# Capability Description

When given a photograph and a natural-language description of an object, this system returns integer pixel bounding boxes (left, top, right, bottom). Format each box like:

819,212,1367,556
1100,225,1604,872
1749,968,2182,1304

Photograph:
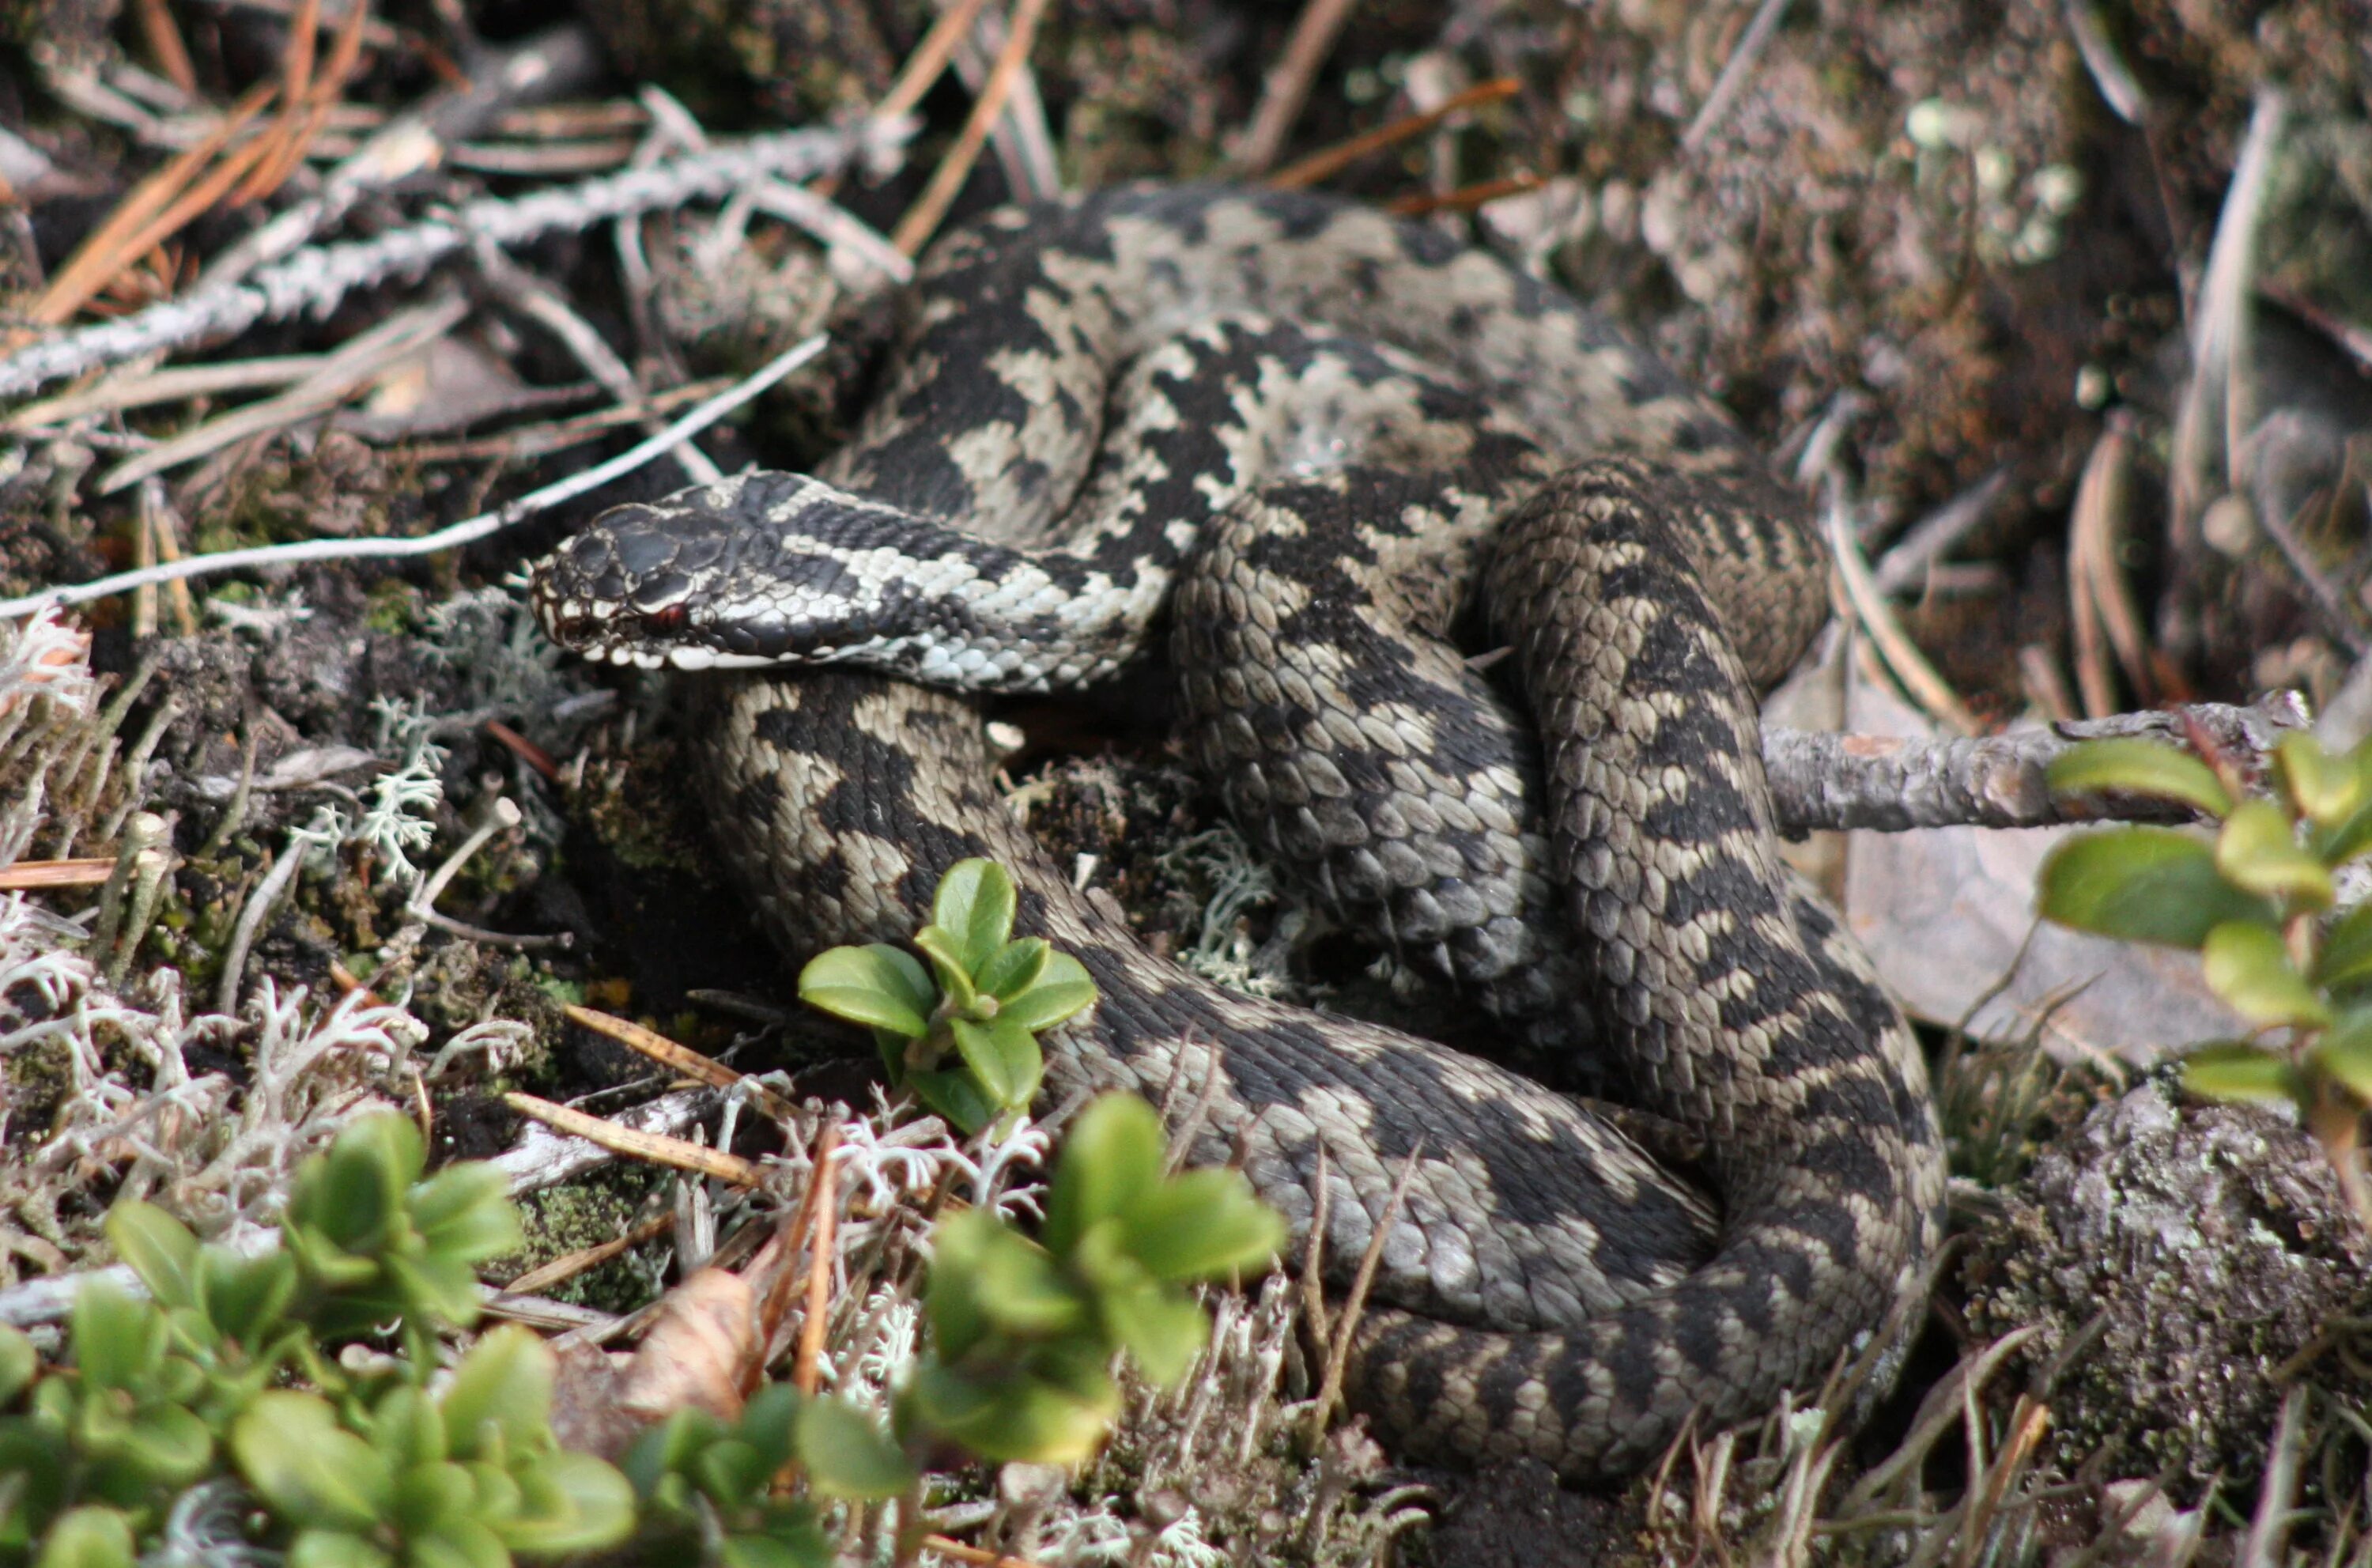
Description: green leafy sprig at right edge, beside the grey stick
2038,735,2372,1224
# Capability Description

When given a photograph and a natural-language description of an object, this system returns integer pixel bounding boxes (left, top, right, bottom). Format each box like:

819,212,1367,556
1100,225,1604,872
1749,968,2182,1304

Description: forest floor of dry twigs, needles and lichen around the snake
0,0,2372,1568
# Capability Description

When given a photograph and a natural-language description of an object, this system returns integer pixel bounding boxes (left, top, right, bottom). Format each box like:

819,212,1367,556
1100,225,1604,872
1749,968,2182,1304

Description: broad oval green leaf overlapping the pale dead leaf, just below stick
2035,828,2279,949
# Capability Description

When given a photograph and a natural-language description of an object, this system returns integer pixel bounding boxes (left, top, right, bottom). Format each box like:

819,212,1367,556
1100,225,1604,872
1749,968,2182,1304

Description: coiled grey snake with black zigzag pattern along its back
534,187,1943,1478
